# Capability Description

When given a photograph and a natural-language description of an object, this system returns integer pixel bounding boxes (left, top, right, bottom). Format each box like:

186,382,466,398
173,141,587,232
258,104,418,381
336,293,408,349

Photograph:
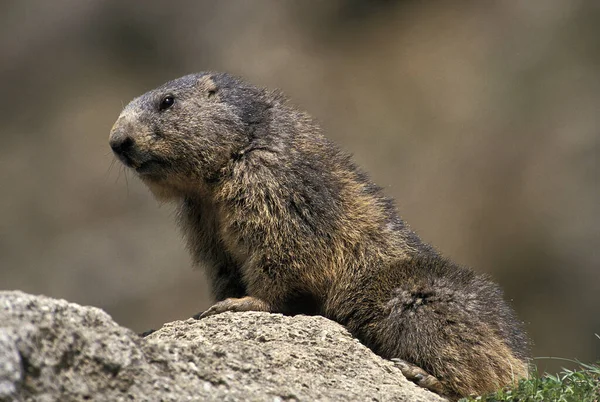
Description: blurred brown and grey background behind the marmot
0,0,600,371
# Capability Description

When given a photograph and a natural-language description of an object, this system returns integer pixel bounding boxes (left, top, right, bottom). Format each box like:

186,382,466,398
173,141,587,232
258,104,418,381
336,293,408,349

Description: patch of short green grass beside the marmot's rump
461,362,600,402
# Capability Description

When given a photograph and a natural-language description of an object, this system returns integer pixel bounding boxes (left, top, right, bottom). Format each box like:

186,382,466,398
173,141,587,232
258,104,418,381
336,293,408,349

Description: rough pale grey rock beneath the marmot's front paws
0,291,443,401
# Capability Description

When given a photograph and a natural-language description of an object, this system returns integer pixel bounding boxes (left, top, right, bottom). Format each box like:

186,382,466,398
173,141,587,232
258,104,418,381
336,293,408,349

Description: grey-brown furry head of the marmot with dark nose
109,73,271,199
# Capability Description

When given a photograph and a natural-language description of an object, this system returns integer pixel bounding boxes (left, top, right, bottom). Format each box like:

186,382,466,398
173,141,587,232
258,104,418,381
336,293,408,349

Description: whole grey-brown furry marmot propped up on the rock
110,72,528,399
